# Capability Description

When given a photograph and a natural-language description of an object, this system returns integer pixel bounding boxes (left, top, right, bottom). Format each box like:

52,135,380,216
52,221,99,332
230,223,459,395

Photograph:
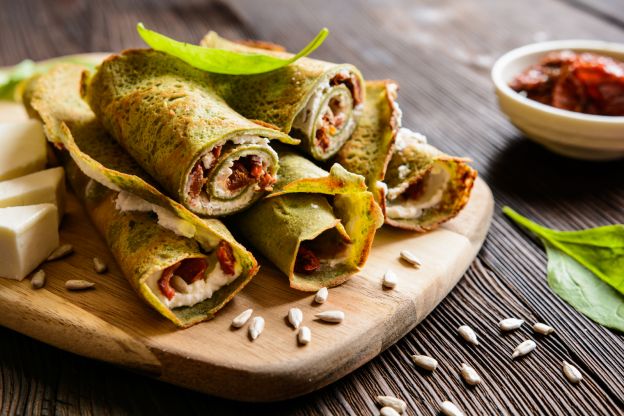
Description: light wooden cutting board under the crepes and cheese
0,63,494,401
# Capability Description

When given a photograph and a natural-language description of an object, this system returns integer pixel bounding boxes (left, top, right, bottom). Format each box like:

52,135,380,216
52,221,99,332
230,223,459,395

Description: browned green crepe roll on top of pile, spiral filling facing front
83,50,298,216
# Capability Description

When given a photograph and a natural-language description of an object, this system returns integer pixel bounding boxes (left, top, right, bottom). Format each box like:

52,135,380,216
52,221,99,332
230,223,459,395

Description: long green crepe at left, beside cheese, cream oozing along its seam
24,64,258,327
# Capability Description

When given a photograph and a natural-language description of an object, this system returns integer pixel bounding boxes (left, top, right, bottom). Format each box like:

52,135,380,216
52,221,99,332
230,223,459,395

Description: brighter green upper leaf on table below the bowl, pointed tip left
503,207,624,294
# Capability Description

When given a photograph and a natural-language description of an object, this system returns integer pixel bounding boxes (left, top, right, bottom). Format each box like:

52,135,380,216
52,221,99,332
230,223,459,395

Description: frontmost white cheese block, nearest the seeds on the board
0,204,59,280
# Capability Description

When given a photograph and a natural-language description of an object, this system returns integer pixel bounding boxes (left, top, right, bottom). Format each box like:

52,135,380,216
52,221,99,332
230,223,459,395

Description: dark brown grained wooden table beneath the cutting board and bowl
0,0,624,415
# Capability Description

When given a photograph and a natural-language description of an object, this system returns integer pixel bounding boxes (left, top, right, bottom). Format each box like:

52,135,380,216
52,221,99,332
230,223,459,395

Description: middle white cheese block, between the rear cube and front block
0,167,65,222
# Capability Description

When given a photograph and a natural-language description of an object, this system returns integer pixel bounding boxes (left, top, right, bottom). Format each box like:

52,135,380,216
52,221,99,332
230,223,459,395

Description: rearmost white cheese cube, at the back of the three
0,120,47,181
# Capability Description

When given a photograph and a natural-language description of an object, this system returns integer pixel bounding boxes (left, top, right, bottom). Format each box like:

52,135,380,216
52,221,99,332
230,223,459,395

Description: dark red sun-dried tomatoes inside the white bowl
509,50,624,116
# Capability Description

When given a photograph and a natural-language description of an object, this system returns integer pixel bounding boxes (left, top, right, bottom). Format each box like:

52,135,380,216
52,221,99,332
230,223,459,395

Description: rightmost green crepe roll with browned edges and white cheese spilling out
336,81,477,232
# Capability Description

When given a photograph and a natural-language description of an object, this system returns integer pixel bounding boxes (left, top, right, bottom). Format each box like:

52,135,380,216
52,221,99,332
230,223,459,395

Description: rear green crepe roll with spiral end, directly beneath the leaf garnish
201,32,365,160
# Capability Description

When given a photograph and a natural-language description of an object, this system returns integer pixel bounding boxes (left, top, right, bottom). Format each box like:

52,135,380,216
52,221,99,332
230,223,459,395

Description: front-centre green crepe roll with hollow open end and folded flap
233,148,383,291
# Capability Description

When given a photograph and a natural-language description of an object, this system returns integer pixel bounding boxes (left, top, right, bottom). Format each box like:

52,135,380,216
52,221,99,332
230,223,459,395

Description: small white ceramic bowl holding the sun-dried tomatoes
492,40,624,160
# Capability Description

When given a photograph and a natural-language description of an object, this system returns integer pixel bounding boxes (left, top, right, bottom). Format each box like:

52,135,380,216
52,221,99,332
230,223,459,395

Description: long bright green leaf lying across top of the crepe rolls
137,23,329,75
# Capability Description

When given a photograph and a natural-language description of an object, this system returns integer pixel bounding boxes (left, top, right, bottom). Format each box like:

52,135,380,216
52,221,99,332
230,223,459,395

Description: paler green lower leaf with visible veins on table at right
544,241,624,332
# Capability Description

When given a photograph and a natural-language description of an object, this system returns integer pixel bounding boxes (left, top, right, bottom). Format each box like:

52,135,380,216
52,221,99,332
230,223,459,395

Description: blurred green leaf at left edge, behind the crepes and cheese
0,56,94,101
